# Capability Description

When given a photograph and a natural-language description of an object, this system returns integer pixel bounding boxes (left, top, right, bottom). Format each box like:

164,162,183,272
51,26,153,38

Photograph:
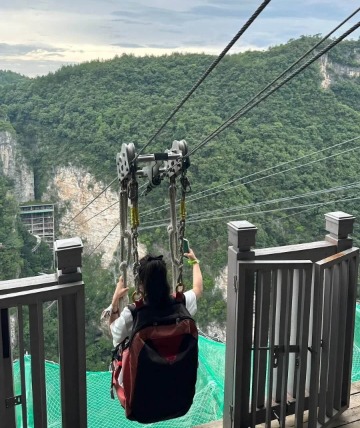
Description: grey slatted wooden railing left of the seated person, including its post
0,238,87,428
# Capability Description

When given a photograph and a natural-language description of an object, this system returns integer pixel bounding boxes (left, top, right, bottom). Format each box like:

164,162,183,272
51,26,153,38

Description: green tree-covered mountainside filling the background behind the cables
0,37,360,368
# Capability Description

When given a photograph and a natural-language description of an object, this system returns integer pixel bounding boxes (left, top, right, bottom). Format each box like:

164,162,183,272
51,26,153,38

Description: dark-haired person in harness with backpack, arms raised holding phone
109,249,203,423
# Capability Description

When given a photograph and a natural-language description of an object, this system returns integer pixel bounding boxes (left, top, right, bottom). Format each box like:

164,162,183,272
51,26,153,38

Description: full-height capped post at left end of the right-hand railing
224,221,257,428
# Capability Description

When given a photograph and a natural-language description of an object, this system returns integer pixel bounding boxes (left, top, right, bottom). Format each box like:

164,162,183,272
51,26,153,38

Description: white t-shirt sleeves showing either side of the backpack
110,290,197,346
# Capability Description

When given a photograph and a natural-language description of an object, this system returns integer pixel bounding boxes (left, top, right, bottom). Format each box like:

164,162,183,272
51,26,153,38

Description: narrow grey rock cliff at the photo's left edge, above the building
0,131,34,203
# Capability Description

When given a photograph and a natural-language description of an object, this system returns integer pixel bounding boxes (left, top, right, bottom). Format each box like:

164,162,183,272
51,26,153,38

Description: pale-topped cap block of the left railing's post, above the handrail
54,237,83,284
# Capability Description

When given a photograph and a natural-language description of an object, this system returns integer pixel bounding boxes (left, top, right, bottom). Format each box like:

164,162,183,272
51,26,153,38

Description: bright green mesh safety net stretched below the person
14,304,360,428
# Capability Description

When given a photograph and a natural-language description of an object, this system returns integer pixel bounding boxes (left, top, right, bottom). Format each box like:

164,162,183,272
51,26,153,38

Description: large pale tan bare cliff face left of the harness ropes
43,166,144,267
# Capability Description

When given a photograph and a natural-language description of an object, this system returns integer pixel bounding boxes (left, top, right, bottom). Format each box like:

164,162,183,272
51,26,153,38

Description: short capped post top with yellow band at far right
325,211,355,253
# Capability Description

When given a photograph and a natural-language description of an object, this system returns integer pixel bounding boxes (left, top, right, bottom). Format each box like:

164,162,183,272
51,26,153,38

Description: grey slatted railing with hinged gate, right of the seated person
224,212,359,428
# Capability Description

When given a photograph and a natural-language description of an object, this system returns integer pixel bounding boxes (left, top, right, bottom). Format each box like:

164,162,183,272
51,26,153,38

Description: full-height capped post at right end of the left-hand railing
54,238,87,428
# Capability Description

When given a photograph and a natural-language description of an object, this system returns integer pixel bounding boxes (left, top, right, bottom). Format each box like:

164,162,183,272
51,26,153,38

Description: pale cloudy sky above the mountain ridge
0,0,360,77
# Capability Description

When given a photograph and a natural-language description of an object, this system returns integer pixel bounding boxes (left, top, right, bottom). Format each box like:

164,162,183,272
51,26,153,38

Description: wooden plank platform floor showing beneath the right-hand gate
195,382,360,428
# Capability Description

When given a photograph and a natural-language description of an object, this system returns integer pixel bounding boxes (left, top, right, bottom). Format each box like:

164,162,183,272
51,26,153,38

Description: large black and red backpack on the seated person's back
111,293,198,423
